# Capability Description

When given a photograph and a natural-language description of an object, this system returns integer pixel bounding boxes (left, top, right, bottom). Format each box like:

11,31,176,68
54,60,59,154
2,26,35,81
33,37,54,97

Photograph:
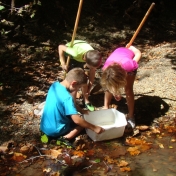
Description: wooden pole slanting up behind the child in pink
126,3,155,48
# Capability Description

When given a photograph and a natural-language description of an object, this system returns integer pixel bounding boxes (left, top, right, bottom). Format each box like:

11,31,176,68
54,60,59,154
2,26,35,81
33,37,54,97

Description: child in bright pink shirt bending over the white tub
101,46,141,128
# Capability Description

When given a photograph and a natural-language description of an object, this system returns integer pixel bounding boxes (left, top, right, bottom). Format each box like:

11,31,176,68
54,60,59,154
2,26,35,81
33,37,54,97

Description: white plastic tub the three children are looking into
83,109,127,141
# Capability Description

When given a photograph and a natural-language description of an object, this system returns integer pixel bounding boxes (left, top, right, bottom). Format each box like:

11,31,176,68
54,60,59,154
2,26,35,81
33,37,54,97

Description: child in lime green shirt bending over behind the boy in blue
58,40,102,111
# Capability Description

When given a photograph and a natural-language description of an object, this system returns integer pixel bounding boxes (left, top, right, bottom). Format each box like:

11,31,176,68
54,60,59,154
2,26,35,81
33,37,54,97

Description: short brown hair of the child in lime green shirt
85,50,102,67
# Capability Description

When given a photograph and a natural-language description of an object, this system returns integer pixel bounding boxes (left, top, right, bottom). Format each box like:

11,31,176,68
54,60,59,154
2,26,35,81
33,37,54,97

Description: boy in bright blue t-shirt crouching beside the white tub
40,68,104,140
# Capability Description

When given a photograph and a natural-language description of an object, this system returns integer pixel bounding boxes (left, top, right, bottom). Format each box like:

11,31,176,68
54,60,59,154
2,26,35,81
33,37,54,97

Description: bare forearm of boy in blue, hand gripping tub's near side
71,114,105,134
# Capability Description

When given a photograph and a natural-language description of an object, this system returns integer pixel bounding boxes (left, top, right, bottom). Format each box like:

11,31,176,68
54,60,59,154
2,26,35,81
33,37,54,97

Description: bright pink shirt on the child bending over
103,47,138,72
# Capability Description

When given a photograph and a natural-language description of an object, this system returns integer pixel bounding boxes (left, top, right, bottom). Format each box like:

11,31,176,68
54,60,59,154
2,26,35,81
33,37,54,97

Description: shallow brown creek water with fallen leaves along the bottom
9,136,176,176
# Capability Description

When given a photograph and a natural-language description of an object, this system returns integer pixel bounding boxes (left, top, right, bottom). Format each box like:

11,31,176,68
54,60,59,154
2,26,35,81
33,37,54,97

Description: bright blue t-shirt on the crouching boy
40,82,77,137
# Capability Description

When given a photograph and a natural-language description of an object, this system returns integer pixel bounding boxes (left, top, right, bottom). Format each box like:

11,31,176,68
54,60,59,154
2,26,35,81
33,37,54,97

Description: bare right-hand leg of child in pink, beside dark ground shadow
125,74,135,118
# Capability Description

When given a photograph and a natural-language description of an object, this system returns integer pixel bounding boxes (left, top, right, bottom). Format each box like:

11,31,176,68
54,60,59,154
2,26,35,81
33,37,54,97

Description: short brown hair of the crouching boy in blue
65,68,87,85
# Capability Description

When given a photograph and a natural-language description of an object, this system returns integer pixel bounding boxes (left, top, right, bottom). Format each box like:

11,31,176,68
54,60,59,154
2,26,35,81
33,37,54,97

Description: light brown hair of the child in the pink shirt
101,63,127,95
